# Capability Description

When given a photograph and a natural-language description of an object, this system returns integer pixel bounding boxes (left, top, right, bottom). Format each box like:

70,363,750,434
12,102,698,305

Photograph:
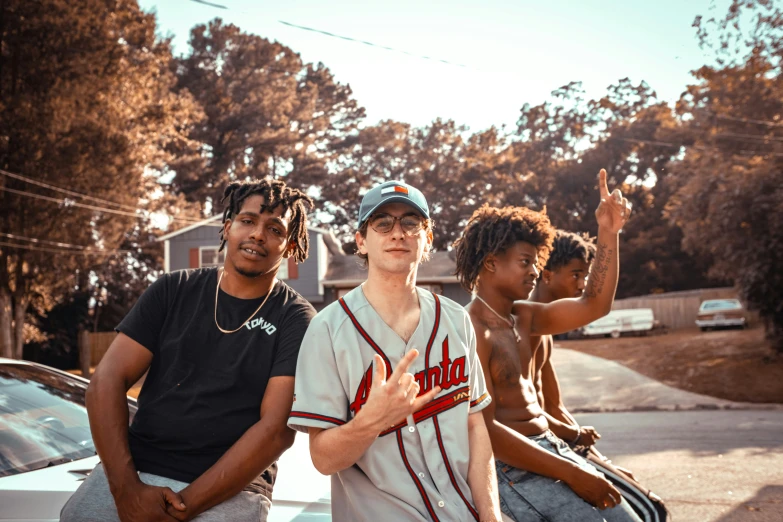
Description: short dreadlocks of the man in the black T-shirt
218,178,313,263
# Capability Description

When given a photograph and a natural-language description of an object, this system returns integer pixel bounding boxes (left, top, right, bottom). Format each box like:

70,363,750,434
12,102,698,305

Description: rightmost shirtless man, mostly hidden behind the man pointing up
530,230,669,522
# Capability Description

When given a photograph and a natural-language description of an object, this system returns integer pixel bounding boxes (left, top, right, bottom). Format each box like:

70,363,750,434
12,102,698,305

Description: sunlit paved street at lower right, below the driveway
575,410,783,522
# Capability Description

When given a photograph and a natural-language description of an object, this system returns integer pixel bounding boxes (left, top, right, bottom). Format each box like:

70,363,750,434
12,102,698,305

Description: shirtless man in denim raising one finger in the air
456,170,639,522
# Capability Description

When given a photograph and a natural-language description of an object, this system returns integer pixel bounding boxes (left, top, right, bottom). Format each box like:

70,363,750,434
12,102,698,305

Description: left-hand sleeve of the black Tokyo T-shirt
115,274,172,354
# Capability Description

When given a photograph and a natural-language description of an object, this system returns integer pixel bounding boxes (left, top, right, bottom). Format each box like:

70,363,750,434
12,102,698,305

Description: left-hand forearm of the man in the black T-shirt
86,373,140,496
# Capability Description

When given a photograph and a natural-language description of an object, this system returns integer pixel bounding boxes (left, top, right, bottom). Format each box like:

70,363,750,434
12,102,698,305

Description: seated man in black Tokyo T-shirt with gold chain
61,180,315,522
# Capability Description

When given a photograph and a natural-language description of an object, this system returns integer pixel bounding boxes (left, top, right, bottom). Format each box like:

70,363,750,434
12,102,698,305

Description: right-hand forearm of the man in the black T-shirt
176,418,295,519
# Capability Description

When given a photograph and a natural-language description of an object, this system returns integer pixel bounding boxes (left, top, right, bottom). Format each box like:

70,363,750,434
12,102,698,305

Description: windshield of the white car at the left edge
0,364,129,477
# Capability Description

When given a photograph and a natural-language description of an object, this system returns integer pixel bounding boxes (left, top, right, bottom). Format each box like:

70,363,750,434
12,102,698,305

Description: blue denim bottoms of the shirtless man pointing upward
495,431,641,522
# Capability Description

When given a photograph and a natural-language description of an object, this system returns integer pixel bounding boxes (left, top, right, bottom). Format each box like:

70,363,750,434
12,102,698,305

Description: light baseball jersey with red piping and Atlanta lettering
288,287,491,522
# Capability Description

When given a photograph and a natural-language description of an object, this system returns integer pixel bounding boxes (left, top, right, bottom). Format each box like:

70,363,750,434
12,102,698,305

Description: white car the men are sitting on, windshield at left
0,358,331,522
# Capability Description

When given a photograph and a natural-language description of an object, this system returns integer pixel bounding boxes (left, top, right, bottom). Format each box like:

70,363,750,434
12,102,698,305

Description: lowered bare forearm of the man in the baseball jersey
468,413,501,522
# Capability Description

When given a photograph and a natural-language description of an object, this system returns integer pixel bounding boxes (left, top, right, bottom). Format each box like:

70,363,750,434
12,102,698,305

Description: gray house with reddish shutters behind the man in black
158,215,334,310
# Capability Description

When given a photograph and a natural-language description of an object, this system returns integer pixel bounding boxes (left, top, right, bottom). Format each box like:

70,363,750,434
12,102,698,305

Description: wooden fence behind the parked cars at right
612,288,758,329
